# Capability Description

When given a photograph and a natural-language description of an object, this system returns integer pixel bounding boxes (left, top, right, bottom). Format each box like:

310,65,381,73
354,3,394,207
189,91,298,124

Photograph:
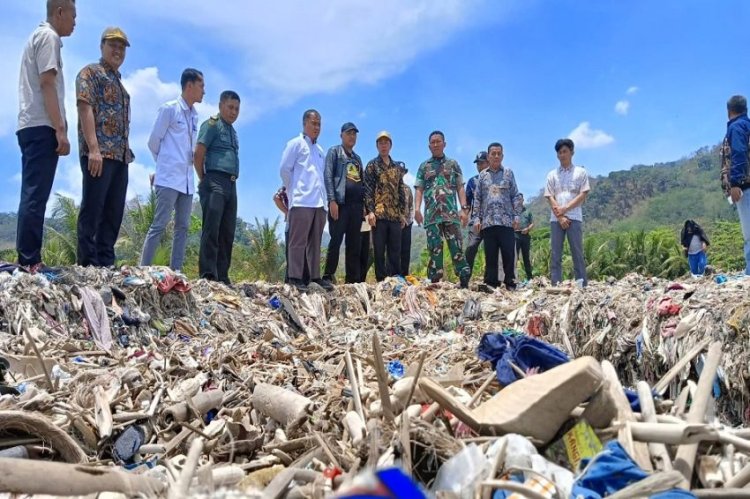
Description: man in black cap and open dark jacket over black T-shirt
323,122,364,283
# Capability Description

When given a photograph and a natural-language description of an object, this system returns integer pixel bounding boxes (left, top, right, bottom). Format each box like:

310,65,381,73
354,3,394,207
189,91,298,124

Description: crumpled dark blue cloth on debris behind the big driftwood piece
477,331,570,386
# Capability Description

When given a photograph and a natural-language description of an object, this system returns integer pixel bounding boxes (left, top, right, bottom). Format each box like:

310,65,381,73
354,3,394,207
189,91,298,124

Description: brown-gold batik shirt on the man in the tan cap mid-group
365,156,406,222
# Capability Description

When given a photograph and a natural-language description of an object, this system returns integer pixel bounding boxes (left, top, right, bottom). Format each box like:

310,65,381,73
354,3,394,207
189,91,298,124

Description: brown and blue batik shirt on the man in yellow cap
76,59,134,164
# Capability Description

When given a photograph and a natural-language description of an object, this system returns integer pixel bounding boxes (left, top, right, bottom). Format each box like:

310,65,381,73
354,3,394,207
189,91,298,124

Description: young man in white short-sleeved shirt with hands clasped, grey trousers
544,139,591,286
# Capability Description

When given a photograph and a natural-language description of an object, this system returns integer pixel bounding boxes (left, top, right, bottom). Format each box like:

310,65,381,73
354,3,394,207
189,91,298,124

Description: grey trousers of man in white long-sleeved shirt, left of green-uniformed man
141,185,193,271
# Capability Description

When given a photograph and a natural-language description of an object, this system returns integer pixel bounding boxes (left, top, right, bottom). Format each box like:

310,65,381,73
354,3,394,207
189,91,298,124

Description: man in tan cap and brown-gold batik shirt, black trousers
365,131,406,281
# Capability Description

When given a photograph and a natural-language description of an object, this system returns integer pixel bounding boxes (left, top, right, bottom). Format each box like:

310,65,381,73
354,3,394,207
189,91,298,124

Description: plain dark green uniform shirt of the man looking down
198,114,240,177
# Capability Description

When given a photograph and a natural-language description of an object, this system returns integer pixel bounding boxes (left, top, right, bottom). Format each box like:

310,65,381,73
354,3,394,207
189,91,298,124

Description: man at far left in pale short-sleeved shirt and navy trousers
16,0,76,272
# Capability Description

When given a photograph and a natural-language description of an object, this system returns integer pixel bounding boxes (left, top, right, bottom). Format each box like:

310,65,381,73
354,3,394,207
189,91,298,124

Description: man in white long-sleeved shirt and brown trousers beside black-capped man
279,109,333,292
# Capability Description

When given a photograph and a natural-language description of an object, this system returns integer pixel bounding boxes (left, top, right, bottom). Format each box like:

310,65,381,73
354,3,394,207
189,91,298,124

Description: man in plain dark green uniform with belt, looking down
194,90,240,284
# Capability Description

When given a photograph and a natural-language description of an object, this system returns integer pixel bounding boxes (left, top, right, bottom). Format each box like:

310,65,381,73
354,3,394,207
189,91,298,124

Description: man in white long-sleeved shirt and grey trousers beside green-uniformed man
141,68,205,271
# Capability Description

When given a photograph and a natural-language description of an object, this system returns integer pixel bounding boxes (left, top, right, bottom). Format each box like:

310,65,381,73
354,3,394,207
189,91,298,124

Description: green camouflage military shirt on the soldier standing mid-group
414,156,464,227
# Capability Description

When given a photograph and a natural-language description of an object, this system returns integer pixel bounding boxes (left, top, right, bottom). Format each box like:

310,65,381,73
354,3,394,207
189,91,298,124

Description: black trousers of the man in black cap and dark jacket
323,203,363,283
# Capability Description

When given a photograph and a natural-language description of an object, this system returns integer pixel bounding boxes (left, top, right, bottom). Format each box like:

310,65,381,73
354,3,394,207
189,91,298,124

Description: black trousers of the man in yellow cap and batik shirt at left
78,156,128,267
